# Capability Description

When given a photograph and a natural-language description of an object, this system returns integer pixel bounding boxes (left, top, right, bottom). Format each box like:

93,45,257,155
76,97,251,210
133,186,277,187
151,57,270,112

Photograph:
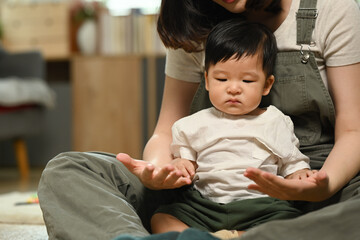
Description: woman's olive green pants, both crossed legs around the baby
38,152,360,240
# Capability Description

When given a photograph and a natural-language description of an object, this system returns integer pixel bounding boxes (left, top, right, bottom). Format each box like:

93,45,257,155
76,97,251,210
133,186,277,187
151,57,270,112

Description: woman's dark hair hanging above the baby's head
157,0,281,52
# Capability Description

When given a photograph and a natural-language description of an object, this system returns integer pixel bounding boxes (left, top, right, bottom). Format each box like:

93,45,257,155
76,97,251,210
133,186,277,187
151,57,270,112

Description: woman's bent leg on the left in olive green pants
38,152,149,240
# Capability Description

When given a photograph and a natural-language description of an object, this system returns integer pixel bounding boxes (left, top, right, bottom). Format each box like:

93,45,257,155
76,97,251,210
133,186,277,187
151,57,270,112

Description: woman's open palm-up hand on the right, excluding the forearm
244,168,331,202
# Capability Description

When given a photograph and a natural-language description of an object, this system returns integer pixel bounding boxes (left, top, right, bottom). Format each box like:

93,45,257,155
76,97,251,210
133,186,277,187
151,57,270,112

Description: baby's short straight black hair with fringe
205,19,277,76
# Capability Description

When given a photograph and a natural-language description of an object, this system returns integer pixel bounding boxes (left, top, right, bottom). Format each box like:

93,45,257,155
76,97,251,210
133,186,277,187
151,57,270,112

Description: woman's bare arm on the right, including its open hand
245,63,360,201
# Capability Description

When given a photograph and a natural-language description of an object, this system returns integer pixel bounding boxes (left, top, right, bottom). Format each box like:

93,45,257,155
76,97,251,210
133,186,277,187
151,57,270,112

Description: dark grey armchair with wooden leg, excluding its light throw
0,46,45,179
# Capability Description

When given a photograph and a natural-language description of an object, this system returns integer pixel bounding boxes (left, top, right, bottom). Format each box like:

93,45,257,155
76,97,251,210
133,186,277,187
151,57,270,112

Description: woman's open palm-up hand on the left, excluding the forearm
116,153,191,190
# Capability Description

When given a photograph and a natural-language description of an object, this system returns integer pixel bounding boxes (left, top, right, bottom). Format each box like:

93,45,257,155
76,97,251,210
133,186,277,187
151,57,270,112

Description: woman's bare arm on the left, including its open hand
117,76,198,189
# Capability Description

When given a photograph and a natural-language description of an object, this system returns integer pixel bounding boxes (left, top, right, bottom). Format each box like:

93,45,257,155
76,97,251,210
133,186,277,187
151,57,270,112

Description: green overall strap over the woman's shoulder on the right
296,0,318,45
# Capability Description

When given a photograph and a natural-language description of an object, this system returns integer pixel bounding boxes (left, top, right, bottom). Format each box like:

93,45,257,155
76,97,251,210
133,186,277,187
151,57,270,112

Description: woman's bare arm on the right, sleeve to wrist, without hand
322,63,360,193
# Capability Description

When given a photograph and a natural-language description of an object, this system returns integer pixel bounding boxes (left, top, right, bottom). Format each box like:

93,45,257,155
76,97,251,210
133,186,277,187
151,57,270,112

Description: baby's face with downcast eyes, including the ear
205,54,273,115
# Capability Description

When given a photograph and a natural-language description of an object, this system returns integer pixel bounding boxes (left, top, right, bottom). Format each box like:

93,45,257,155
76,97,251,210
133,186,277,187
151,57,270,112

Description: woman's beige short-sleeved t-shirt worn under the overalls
165,0,360,89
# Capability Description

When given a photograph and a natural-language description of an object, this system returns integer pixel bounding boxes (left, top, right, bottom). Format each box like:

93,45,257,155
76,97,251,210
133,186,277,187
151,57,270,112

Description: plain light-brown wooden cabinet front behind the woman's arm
72,56,144,158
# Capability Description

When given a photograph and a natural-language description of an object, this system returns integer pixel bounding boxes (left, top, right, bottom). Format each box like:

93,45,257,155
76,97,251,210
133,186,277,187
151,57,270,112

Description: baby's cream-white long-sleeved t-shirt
171,106,310,203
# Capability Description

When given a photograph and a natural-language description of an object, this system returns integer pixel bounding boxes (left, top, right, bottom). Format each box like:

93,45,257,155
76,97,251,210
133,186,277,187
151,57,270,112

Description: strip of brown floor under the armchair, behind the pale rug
0,167,43,194
